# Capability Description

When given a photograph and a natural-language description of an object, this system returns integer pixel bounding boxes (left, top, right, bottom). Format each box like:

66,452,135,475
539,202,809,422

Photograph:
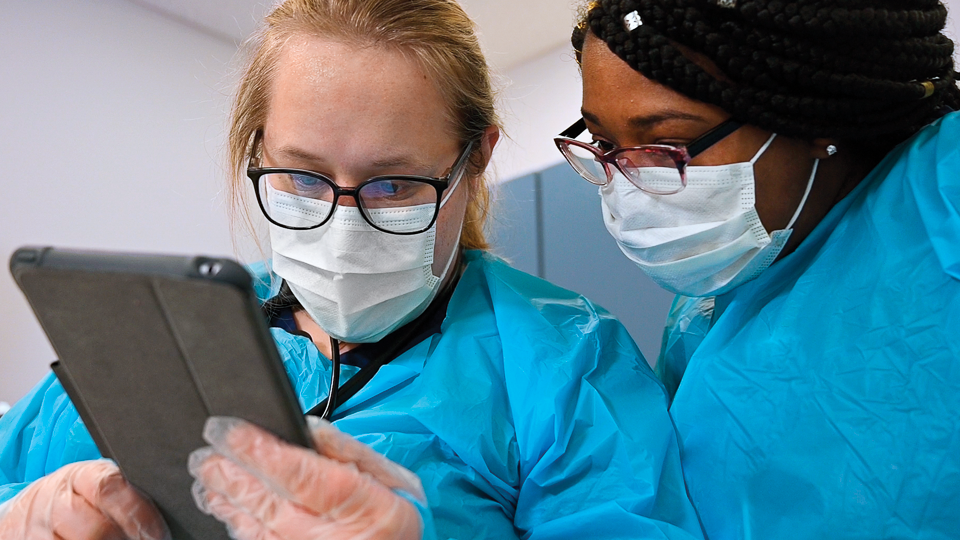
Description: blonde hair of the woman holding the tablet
227,0,499,249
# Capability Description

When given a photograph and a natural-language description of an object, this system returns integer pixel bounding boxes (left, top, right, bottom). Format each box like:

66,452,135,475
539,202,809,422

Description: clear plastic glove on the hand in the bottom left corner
0,460,170,540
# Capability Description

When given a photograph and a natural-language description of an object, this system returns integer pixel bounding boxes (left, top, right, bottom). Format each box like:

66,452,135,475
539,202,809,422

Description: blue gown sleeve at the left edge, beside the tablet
0,373,100,503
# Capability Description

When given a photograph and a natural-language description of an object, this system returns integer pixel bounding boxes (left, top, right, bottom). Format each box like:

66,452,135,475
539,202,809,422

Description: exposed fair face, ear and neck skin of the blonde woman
263,35,499,357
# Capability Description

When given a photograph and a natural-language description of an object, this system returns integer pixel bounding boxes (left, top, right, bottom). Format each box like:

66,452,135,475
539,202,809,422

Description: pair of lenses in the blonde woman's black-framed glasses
257,172,438,234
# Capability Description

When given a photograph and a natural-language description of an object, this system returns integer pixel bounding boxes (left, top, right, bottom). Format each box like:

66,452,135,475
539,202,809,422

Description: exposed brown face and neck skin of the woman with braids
581,34,872,257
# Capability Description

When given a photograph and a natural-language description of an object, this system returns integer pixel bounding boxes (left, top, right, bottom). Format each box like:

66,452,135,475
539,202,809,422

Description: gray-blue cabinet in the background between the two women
487,163,673,364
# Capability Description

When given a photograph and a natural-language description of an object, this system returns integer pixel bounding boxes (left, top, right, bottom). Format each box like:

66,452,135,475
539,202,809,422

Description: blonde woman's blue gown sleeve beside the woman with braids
491,270,702,539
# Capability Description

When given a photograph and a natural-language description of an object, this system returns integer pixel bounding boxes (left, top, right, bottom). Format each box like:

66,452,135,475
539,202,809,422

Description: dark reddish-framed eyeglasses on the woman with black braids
553,118,743,195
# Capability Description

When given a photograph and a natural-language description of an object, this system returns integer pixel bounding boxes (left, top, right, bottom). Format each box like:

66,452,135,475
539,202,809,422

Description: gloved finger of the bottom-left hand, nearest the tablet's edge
73,460,170,540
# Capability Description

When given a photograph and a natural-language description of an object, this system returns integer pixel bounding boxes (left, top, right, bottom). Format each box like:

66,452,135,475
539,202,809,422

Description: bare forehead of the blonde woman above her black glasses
266,35,455,157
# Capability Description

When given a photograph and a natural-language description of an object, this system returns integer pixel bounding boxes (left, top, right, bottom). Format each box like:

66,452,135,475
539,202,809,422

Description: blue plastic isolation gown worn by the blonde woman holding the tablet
0,252,702,539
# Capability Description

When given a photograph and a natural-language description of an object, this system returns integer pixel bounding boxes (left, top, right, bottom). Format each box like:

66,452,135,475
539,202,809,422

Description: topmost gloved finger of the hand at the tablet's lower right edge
307,416,427,504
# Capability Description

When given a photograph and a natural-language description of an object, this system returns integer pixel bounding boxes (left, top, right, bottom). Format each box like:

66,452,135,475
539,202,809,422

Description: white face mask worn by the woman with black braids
600,135,819,296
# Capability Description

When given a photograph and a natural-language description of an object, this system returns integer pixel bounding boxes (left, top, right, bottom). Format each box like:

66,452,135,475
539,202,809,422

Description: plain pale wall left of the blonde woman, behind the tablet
0,0,236,403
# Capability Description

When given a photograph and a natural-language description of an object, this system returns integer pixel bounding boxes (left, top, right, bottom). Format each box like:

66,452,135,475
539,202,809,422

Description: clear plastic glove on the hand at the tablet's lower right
189,417,425,540
